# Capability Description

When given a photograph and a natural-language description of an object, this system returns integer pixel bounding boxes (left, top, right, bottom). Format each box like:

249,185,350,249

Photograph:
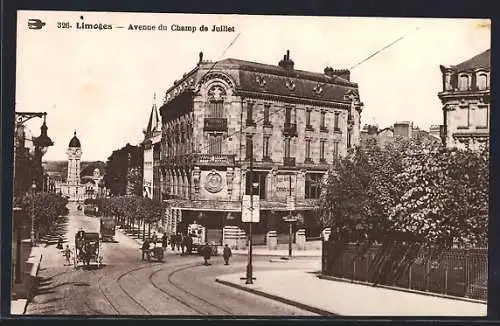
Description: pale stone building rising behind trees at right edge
438,49,491,148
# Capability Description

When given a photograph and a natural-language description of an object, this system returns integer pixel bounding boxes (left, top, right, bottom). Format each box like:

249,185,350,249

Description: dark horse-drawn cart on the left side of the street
73,231,103,269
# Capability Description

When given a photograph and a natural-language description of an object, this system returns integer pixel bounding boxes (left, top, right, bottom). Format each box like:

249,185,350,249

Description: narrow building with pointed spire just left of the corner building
143,94,161,200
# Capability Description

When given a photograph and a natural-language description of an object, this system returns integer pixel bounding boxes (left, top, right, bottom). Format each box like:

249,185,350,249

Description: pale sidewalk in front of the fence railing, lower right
216,270,487,317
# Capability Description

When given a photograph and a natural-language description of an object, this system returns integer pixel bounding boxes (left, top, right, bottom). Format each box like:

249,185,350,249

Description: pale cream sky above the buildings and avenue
15,11,491,161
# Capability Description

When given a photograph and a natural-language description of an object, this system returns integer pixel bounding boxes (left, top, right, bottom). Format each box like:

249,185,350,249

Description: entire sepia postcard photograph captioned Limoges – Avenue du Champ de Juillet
10,10,491,318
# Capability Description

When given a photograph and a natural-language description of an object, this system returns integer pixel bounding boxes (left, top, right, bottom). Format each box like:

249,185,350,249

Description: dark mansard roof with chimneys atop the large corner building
165,53,359,109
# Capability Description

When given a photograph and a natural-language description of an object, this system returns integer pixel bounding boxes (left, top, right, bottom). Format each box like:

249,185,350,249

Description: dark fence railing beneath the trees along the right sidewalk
322,242,488,301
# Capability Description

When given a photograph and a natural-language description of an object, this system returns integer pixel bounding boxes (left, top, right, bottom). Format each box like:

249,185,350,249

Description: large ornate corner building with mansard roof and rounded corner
160,51,363,244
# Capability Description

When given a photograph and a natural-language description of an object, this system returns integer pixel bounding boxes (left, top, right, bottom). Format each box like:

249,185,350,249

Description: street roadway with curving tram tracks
26,207,314,316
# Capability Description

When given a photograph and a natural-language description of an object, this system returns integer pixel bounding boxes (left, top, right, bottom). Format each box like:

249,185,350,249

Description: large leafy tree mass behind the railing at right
321,139,489,282
